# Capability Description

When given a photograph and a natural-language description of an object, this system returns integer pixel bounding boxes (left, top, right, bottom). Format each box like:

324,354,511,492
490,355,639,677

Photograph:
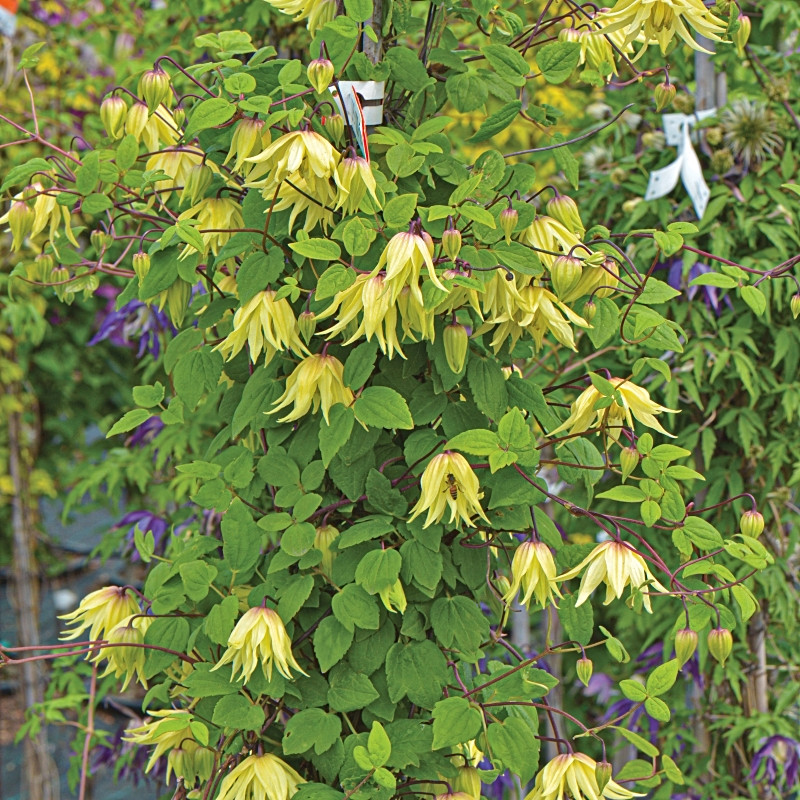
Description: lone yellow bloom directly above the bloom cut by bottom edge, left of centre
211,606,306,683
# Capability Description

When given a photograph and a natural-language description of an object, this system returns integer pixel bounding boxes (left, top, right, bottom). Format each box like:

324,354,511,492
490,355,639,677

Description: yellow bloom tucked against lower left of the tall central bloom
317,273,405,358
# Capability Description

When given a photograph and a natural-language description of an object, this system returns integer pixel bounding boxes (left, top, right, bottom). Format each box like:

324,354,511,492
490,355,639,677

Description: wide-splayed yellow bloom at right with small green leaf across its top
550,378,678,441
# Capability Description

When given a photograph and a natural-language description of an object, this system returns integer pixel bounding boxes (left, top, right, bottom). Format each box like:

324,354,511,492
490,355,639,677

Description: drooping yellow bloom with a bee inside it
409,450,489,528
